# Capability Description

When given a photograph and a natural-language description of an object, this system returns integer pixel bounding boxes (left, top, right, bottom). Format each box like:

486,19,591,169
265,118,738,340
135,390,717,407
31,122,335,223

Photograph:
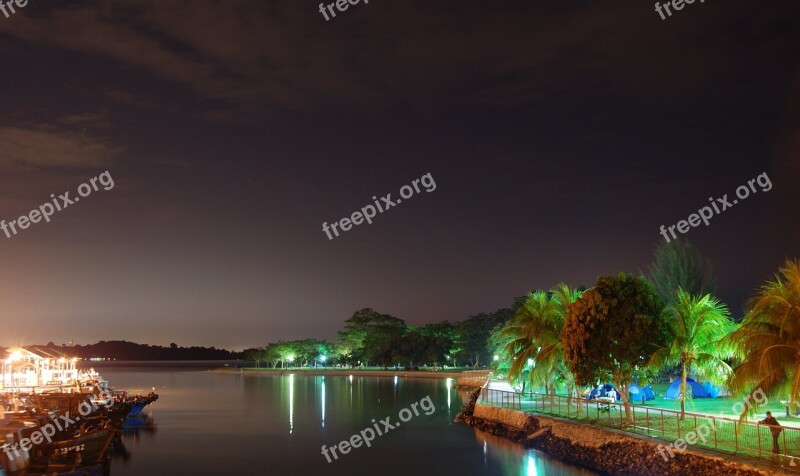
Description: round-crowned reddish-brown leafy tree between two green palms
561,273,667,420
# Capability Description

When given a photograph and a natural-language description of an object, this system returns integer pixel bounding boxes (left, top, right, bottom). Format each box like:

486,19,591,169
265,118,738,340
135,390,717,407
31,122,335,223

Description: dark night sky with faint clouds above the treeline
0,0,800,349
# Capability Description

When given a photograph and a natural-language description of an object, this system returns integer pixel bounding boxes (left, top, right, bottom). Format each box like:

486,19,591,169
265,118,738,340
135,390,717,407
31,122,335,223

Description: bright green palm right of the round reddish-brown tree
648,288,736,419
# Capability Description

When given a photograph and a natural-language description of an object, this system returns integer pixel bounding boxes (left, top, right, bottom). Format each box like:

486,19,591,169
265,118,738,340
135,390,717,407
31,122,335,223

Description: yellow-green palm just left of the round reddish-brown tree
501,284,580,396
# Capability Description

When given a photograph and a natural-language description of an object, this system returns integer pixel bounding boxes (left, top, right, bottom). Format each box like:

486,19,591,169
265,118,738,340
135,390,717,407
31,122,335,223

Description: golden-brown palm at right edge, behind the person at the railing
729,260,800,418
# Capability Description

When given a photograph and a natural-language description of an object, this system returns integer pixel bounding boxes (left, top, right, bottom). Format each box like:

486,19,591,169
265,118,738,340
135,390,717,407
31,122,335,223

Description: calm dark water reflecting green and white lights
101,368,592,476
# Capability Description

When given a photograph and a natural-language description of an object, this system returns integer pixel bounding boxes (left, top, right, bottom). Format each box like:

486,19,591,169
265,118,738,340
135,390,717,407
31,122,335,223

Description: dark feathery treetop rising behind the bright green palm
648,238,716,303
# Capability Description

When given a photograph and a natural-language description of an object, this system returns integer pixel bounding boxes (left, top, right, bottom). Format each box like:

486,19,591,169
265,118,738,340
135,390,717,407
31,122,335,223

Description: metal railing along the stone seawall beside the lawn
478,388,800,463
